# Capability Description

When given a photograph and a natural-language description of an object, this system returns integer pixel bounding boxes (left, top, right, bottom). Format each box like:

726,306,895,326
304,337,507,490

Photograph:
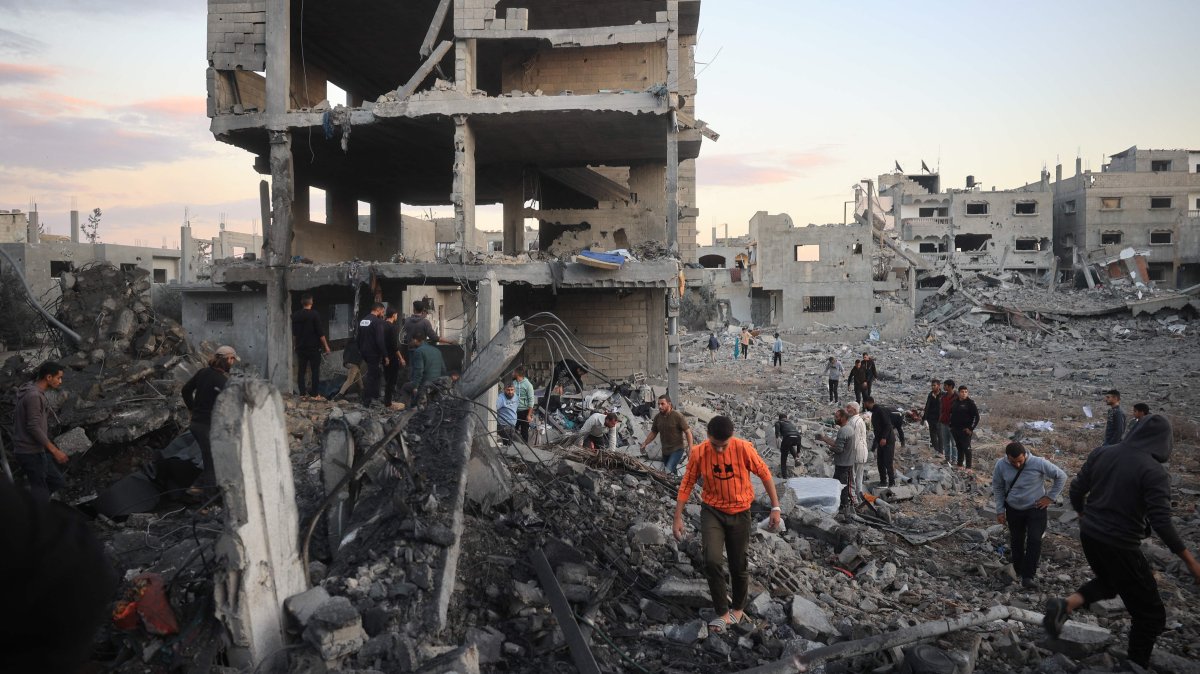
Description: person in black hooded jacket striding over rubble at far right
1043,414,1200,667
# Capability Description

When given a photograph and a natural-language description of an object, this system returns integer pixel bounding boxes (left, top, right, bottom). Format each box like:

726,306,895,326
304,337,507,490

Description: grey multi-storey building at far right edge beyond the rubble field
1054,146,1200,288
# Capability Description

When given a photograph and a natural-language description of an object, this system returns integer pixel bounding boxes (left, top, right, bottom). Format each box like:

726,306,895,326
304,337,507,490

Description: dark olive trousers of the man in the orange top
700,505,750,616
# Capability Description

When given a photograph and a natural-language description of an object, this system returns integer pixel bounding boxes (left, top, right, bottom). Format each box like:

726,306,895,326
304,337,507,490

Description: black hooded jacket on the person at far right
1070,414,1184,554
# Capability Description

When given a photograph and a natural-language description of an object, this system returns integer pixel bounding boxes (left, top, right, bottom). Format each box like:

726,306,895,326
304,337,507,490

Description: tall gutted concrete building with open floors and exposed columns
201,0,716,389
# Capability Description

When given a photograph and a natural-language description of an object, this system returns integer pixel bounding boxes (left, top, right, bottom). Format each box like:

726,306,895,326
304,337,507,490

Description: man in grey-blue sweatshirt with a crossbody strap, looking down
991,443,1067,589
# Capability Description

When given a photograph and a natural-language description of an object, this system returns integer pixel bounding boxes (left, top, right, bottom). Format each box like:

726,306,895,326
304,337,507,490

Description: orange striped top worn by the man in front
678,438,772,514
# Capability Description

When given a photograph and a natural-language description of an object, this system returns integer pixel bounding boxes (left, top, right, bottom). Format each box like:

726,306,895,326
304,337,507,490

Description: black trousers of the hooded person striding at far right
1078,534,1166,667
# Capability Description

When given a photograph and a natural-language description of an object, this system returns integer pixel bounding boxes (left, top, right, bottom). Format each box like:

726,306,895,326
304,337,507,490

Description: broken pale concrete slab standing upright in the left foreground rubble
211,379,308,672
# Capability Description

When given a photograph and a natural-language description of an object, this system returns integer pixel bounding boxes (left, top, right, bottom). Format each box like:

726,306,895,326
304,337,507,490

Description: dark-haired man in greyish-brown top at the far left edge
12,361,67,503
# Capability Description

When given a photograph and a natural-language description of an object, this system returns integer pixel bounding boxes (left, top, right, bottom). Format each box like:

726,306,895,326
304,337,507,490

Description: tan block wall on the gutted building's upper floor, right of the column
500,43,667,95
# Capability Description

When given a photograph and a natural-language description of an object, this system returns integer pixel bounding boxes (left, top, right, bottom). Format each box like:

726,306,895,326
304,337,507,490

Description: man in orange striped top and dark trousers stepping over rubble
674,416,780,632
